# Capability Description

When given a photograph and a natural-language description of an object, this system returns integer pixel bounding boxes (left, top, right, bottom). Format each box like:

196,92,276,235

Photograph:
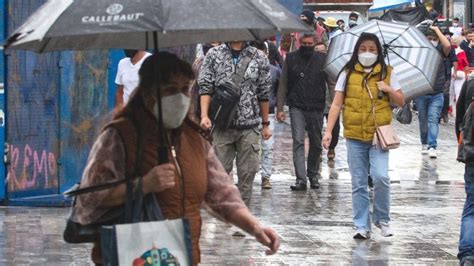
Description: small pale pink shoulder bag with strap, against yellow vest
364,73,400,151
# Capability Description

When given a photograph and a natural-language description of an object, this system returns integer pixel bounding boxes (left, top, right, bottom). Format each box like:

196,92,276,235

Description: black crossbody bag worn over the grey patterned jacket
209,51,257,130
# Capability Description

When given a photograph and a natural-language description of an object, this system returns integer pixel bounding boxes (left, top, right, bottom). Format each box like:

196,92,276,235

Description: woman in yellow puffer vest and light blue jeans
323,33,405,239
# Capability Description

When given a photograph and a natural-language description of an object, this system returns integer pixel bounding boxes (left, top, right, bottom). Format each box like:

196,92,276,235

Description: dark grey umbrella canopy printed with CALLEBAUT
6,0,309,52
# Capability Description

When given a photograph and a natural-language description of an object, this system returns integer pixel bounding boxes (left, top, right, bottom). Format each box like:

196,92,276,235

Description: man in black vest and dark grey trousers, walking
277,33,327,190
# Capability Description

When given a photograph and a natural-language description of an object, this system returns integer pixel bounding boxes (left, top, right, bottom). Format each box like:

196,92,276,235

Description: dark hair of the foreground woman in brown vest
117,52,194,116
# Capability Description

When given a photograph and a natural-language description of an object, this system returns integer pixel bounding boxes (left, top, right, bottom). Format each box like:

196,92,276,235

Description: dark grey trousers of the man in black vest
290,107,323,184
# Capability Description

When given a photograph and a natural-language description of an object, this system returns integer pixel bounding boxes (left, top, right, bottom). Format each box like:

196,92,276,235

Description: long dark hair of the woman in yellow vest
338,32,387,84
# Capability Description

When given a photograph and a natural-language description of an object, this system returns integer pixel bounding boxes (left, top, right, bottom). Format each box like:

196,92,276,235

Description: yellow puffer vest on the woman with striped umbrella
343,64,392,142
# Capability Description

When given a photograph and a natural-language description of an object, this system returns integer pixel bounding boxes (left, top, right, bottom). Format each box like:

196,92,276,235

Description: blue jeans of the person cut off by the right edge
458,163,474,263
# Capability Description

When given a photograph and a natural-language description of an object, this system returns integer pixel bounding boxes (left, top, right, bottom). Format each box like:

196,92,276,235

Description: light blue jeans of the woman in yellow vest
346,139,390,231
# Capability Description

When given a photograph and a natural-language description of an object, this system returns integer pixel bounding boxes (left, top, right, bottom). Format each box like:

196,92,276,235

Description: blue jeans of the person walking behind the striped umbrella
415,92,444,149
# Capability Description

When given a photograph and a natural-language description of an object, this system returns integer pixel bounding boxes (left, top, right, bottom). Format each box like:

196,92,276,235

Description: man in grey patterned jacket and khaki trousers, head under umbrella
198,41,272,206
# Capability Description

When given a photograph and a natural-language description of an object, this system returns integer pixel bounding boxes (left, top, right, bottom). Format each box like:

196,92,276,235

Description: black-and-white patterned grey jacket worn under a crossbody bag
198,44,272,128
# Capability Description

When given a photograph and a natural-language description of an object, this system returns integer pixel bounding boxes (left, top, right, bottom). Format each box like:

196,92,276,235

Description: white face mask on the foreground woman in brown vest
153,93,191,129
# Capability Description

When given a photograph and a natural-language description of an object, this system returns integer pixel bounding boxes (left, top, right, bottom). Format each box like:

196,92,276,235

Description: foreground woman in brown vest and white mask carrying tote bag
65,52,279,265
